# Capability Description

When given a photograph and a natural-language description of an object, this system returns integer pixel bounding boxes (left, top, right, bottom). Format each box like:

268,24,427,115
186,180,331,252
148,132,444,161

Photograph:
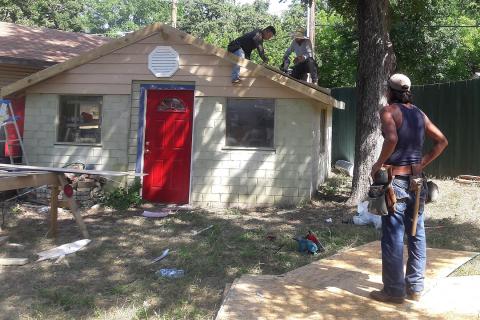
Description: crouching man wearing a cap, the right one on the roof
280,28,318,84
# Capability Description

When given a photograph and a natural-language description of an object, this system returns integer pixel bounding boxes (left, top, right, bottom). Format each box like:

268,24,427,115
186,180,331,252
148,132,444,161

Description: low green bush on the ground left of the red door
102,178,143,210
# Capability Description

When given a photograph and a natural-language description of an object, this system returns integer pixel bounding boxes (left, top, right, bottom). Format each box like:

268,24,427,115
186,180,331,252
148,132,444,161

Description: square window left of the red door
57,96,103,144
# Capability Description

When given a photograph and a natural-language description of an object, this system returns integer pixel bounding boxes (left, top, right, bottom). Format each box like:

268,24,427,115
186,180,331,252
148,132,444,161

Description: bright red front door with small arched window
143,90,193,204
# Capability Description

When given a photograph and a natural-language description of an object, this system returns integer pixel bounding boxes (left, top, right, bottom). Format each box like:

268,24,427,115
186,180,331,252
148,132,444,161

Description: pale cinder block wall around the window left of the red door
24,94,131,171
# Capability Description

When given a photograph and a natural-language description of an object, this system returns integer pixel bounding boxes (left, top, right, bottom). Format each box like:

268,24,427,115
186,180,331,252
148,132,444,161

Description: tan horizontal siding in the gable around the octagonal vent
27,34,304,98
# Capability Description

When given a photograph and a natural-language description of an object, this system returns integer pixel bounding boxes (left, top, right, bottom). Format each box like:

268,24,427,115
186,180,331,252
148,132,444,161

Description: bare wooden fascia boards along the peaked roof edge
0,23,344,109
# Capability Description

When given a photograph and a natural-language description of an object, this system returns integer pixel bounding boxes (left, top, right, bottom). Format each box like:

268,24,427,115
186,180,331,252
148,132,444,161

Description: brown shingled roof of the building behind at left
0,22,111,67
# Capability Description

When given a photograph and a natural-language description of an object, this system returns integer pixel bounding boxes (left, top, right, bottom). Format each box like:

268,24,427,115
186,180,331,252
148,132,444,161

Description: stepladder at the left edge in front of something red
0,99,28,165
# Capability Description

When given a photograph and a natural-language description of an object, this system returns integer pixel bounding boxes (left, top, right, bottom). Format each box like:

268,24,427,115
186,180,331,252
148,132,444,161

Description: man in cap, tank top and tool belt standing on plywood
370,74,448,303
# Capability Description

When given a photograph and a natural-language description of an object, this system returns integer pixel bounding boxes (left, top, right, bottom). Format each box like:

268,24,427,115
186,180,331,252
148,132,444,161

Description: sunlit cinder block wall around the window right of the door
190,97,323,207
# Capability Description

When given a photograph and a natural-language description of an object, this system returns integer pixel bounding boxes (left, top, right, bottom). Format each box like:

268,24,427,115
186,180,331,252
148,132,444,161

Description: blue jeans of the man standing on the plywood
382,177,427,297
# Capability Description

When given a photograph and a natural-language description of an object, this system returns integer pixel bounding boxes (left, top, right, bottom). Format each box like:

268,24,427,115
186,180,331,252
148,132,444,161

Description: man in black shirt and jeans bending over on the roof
227,26,277,84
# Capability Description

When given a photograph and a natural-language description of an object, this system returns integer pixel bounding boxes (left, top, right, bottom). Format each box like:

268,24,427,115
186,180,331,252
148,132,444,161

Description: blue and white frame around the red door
135,82,195,203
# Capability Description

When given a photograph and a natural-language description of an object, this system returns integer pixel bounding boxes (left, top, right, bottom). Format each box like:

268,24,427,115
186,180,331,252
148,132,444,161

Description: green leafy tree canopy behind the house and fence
0,0,480,87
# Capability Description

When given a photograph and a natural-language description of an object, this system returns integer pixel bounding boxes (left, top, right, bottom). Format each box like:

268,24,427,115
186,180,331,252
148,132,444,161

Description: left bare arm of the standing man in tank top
370,106,398,178
